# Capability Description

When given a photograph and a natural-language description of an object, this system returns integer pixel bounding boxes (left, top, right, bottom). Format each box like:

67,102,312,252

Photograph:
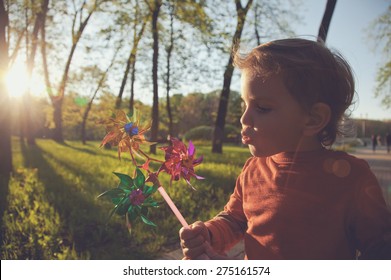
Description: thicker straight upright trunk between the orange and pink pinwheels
150,0,162,154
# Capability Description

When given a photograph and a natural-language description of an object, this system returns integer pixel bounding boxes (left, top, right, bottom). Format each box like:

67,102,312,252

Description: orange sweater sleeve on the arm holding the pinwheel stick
205,159,251,253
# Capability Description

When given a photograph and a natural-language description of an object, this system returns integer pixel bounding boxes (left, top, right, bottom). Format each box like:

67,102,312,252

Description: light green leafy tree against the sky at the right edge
369,5,391,108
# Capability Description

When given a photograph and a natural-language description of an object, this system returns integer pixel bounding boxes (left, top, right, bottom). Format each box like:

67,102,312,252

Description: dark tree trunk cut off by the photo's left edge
0,0,12,178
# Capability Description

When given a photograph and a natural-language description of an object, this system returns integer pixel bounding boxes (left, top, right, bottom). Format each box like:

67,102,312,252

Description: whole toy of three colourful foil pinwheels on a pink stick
98,110,203,231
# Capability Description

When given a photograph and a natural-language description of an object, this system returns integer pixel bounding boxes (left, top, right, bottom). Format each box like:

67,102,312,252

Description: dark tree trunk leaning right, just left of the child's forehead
212,0,253,153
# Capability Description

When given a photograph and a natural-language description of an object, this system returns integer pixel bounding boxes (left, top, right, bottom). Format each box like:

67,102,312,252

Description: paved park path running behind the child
161,146,391,260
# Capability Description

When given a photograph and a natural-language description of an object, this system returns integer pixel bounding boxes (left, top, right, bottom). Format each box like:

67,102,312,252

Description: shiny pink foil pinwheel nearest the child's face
158,138,204,189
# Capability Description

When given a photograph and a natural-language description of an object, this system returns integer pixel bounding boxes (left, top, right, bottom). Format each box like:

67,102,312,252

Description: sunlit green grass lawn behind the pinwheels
0,139,249,259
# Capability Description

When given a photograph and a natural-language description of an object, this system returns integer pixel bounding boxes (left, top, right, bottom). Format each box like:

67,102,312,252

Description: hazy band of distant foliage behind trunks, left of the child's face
12,91,241,142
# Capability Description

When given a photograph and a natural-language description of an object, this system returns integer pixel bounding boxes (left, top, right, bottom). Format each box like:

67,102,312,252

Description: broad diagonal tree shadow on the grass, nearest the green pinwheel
21,143,146,259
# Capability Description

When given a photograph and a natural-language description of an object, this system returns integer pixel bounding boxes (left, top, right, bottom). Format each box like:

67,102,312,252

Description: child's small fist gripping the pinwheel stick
179,221,231,260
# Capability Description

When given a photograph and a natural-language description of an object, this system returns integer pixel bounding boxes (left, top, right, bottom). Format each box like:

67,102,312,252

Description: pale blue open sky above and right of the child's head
295,0,391,120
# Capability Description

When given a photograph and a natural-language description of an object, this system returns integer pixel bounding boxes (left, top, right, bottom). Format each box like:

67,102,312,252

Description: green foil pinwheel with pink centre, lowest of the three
98,168,159,231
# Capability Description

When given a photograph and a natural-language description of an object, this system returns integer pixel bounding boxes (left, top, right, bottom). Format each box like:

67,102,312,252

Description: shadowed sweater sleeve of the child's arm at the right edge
353,164,391,259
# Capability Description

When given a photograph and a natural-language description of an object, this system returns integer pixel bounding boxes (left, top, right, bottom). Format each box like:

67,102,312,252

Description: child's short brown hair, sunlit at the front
233,38,355,146
